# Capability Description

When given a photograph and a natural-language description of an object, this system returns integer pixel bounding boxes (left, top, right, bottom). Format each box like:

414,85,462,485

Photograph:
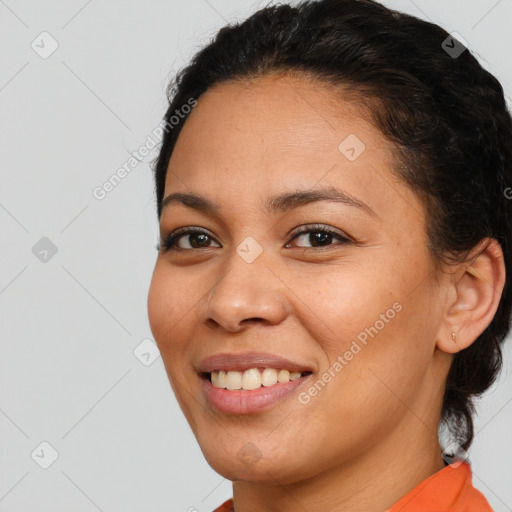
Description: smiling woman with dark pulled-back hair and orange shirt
148,0,512,512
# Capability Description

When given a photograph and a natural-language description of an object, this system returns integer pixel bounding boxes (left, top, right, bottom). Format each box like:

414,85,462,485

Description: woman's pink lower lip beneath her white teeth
203,373,313,414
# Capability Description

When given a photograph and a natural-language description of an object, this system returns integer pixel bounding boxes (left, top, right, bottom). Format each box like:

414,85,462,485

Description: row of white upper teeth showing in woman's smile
210,368,301,391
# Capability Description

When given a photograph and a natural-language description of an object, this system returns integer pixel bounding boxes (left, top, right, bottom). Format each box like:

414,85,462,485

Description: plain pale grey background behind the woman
0,0,512,512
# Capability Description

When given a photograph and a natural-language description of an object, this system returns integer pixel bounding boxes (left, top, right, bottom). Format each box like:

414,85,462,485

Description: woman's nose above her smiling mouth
198,251,290,332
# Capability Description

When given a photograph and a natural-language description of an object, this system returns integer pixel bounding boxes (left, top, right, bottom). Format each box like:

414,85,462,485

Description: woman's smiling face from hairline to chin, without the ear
148,77,449,483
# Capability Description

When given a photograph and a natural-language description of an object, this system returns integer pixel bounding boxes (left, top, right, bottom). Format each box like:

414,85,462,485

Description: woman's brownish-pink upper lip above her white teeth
197,352,313,373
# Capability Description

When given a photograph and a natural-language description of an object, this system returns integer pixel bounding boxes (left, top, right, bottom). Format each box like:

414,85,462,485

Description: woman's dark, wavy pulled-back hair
154,0,512,449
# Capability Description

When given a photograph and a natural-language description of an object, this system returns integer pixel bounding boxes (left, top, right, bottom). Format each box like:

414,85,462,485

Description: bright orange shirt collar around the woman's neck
213,462,494,512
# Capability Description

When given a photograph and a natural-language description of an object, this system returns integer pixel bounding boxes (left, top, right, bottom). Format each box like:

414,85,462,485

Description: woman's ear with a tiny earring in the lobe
436,238,505,354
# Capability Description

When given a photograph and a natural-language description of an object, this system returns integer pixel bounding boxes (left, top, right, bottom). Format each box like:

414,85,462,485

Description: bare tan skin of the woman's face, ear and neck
148,76,504,512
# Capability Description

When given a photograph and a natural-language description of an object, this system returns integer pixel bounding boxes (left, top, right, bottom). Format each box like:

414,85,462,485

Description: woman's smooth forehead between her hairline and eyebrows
164,76,422,224
